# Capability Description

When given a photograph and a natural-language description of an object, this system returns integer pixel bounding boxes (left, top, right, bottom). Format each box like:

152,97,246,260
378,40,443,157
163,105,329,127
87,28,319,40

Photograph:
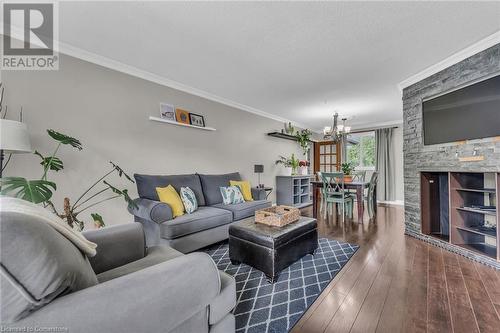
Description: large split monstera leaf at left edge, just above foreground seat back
0,177,56,203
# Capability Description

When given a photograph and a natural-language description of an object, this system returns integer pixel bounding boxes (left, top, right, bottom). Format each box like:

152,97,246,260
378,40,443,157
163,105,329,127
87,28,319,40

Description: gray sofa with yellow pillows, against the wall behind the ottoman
129,172,271,253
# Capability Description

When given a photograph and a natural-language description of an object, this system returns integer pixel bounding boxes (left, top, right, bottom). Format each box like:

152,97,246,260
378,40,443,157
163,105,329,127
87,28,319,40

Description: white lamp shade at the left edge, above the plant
0,119,31,154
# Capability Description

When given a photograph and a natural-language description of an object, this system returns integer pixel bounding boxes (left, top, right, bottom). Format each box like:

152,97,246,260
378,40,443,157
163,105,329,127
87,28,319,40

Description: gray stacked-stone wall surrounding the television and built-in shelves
403,44,500,268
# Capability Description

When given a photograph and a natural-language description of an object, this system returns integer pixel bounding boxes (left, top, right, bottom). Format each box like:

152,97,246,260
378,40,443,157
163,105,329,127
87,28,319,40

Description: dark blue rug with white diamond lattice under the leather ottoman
205,238,359,333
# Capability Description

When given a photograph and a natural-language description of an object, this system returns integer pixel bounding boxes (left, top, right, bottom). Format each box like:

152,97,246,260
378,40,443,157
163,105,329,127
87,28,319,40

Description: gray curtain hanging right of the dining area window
375,128,396,201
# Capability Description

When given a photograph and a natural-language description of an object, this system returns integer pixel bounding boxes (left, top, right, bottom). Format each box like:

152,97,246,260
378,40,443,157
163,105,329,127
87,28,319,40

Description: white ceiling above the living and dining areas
55,2,500,130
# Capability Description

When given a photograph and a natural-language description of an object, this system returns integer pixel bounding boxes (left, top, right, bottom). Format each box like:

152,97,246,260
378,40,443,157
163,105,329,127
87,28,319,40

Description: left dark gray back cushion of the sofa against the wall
134,173,205,206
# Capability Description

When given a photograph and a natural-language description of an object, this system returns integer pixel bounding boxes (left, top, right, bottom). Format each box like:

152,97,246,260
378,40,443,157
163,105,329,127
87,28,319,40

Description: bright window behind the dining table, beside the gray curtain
346,131,375,170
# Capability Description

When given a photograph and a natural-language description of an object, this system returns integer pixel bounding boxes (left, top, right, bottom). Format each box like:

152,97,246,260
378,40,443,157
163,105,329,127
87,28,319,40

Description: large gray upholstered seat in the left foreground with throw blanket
0,212,236,333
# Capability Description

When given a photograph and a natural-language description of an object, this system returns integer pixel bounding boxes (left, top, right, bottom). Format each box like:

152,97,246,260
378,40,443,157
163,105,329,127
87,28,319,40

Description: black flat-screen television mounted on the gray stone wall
422,75,500,145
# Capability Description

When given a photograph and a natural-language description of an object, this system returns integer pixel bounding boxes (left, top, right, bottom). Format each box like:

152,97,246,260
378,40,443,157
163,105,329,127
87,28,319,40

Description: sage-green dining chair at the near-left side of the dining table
321,172,354,221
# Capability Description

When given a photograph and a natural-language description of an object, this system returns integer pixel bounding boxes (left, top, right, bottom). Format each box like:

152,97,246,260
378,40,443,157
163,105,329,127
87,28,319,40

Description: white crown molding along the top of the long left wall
2,26,310,128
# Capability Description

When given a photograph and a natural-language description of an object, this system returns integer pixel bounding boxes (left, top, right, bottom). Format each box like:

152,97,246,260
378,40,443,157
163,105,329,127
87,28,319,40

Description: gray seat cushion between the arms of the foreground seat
97,246,183,283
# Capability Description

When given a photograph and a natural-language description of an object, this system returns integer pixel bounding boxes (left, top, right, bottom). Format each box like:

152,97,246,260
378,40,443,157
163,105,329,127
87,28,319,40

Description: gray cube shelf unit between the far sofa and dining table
276,175,314,208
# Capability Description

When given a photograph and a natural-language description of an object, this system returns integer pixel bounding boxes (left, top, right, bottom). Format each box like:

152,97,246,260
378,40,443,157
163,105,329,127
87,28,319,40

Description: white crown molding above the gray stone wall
398,31,500,91
